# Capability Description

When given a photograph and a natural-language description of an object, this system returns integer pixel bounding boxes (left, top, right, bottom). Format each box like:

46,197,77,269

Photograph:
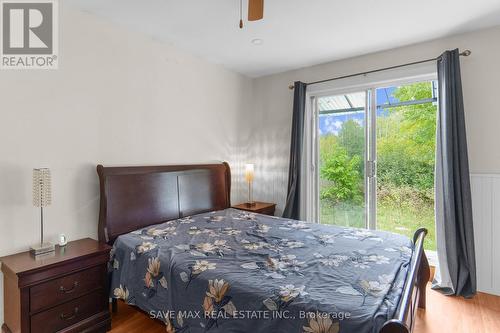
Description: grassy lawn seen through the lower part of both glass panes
320,200,436,251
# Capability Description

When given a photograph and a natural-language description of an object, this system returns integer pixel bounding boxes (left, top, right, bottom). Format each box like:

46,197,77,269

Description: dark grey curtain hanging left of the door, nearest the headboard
283,82,307,219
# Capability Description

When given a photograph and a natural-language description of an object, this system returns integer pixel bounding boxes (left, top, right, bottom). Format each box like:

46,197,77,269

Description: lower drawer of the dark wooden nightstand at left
31,291,106,333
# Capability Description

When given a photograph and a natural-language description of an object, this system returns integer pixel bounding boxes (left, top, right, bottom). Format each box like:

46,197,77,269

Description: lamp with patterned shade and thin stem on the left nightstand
30,168,55,256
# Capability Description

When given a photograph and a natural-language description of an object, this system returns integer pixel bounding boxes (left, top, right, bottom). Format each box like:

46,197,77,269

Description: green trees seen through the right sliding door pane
377,82,437,191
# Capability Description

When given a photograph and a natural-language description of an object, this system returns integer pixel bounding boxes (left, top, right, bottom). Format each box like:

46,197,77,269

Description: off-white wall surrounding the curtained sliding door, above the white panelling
252,27,500,213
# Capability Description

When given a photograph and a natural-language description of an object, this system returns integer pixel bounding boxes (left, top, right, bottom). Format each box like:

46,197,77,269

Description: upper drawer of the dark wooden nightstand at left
30,265,106,312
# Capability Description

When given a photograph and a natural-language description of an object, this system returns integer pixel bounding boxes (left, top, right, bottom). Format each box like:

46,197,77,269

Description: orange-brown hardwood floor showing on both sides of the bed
111,286,500,333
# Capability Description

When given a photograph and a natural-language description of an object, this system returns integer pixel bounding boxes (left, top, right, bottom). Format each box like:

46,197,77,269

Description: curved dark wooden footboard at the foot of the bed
380,228,430,333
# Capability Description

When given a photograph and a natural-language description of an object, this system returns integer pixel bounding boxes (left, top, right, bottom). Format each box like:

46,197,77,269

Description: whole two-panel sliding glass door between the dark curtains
313,81,437,249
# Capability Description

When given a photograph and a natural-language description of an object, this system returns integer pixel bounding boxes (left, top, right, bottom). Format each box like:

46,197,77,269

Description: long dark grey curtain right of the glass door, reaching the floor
433,49,476,297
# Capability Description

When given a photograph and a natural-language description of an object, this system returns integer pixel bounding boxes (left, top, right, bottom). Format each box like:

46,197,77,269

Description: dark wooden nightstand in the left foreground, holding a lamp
0,238,111,333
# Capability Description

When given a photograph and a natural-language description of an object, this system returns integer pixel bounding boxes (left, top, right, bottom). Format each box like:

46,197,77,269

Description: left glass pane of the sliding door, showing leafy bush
316,91,368,228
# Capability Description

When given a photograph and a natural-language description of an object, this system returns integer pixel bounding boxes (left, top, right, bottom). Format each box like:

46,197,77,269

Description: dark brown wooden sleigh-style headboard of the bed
97,162,231,244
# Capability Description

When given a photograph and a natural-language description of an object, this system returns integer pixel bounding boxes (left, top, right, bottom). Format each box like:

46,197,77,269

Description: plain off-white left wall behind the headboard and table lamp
0,3,251,323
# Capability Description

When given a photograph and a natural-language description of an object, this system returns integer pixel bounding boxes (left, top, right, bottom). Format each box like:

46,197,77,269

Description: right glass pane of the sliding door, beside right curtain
376,81,437,250
